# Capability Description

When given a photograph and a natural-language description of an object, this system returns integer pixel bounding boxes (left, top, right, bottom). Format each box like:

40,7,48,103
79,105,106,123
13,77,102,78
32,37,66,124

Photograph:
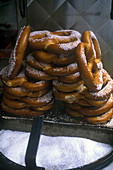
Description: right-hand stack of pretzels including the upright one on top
66,31,113,124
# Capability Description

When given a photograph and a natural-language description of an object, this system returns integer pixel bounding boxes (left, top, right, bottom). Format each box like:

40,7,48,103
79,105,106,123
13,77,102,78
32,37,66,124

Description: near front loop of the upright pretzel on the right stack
76,42,103,92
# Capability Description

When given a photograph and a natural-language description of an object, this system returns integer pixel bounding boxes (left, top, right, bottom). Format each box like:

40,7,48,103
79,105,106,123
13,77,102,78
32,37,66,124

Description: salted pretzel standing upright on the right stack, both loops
77,31,103,91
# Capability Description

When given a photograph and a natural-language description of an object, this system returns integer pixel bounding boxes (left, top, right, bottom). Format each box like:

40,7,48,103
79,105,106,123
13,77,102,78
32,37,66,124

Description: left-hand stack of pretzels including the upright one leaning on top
1,26,54,117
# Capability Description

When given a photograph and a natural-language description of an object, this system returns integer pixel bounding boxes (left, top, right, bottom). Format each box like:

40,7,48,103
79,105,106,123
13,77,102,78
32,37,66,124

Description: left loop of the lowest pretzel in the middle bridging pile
25,65,55,80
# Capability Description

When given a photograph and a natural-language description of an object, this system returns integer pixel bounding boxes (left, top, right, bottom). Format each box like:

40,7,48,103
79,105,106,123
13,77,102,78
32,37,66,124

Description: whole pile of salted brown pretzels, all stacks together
0,26,113,124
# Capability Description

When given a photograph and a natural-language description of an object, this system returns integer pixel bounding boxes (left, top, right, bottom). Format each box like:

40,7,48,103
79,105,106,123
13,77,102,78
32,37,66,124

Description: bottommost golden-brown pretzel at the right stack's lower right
84,108,113,124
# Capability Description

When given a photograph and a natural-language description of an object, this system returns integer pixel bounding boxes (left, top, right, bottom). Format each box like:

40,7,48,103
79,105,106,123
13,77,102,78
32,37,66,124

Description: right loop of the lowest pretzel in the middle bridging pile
57,72,81,83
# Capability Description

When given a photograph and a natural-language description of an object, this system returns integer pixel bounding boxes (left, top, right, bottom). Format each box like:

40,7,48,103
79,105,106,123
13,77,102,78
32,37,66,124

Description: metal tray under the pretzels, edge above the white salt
0,100,113,144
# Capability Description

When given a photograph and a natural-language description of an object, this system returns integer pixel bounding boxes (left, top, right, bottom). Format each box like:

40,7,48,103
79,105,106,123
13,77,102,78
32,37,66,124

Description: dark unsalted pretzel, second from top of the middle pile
34,50,76,66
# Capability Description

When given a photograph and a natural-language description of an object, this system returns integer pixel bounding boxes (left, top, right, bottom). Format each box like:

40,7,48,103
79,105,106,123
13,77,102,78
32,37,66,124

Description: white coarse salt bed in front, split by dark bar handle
0,130,112,170
